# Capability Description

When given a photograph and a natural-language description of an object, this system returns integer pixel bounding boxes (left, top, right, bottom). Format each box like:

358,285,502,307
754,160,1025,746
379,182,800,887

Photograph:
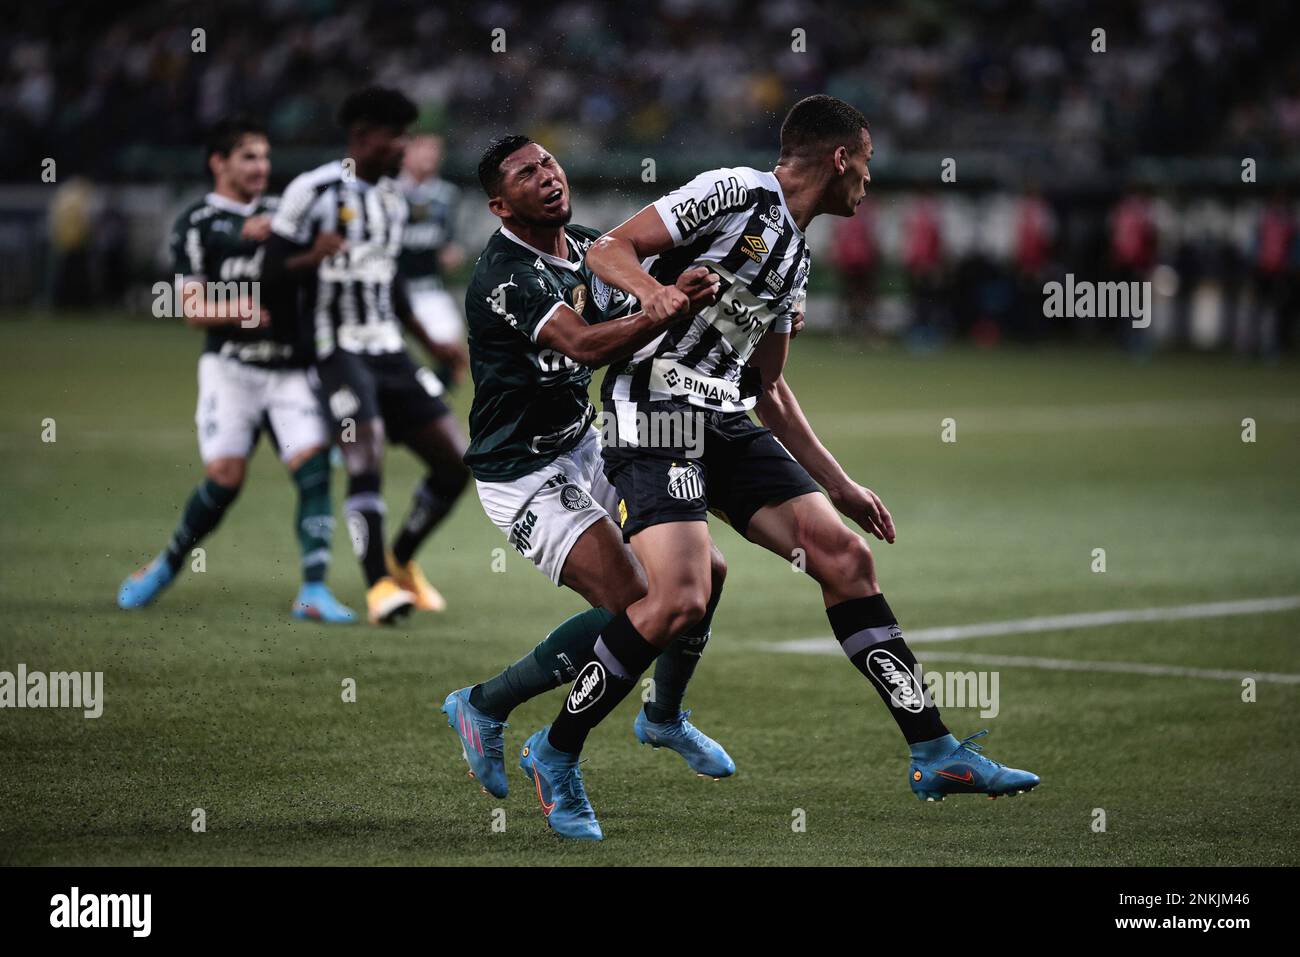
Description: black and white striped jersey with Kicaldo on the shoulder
602,166,811,416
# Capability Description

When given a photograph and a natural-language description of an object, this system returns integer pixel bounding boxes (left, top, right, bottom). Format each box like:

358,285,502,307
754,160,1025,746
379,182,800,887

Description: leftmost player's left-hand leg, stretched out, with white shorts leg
117,354,261,609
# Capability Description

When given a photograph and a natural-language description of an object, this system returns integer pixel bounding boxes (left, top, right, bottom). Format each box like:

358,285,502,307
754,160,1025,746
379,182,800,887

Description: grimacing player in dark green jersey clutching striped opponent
442,135,736,821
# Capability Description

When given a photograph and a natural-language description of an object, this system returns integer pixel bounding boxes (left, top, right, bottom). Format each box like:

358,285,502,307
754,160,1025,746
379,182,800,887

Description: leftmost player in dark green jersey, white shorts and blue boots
117,117,354,622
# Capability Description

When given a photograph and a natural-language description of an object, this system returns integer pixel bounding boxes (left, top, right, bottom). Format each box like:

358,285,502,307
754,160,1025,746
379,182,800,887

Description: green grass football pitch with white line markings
0,316,1300,865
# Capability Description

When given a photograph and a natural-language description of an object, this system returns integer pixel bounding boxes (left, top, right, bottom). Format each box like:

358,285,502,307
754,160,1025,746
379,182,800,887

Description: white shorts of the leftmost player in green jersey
194,352,330,464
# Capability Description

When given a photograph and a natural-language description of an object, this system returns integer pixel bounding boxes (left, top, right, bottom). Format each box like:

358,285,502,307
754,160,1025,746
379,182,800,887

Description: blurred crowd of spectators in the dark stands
0,0,1300,179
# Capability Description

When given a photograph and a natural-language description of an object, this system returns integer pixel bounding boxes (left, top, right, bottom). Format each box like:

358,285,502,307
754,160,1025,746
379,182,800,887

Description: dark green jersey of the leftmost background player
163,192,302,367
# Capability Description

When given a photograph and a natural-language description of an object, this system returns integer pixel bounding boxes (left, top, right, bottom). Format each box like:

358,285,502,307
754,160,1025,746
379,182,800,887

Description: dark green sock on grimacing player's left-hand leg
469,609,614,722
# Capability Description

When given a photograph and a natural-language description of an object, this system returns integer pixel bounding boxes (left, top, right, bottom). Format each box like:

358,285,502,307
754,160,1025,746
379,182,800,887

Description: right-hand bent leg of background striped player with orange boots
374,352,469,611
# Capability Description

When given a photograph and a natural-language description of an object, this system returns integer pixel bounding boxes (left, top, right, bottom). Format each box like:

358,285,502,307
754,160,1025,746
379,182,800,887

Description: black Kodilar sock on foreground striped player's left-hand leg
546,611,659,754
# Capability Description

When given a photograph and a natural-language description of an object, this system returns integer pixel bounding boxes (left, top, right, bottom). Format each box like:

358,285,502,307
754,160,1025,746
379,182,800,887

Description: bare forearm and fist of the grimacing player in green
537,267,718,368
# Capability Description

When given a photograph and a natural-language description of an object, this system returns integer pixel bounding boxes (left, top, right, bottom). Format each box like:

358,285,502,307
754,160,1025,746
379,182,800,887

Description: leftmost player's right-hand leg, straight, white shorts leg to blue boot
267,369,356,622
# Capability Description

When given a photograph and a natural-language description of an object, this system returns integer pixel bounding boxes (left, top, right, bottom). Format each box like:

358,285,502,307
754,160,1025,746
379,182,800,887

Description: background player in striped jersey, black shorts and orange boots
267,87,469,624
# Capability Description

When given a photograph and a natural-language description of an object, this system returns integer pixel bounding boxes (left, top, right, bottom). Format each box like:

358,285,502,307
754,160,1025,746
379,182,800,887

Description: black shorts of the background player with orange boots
312,348,451,442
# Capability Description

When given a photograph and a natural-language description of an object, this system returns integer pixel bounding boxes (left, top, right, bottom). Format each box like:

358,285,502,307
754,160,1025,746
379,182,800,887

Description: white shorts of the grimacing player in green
478,429,619,585
